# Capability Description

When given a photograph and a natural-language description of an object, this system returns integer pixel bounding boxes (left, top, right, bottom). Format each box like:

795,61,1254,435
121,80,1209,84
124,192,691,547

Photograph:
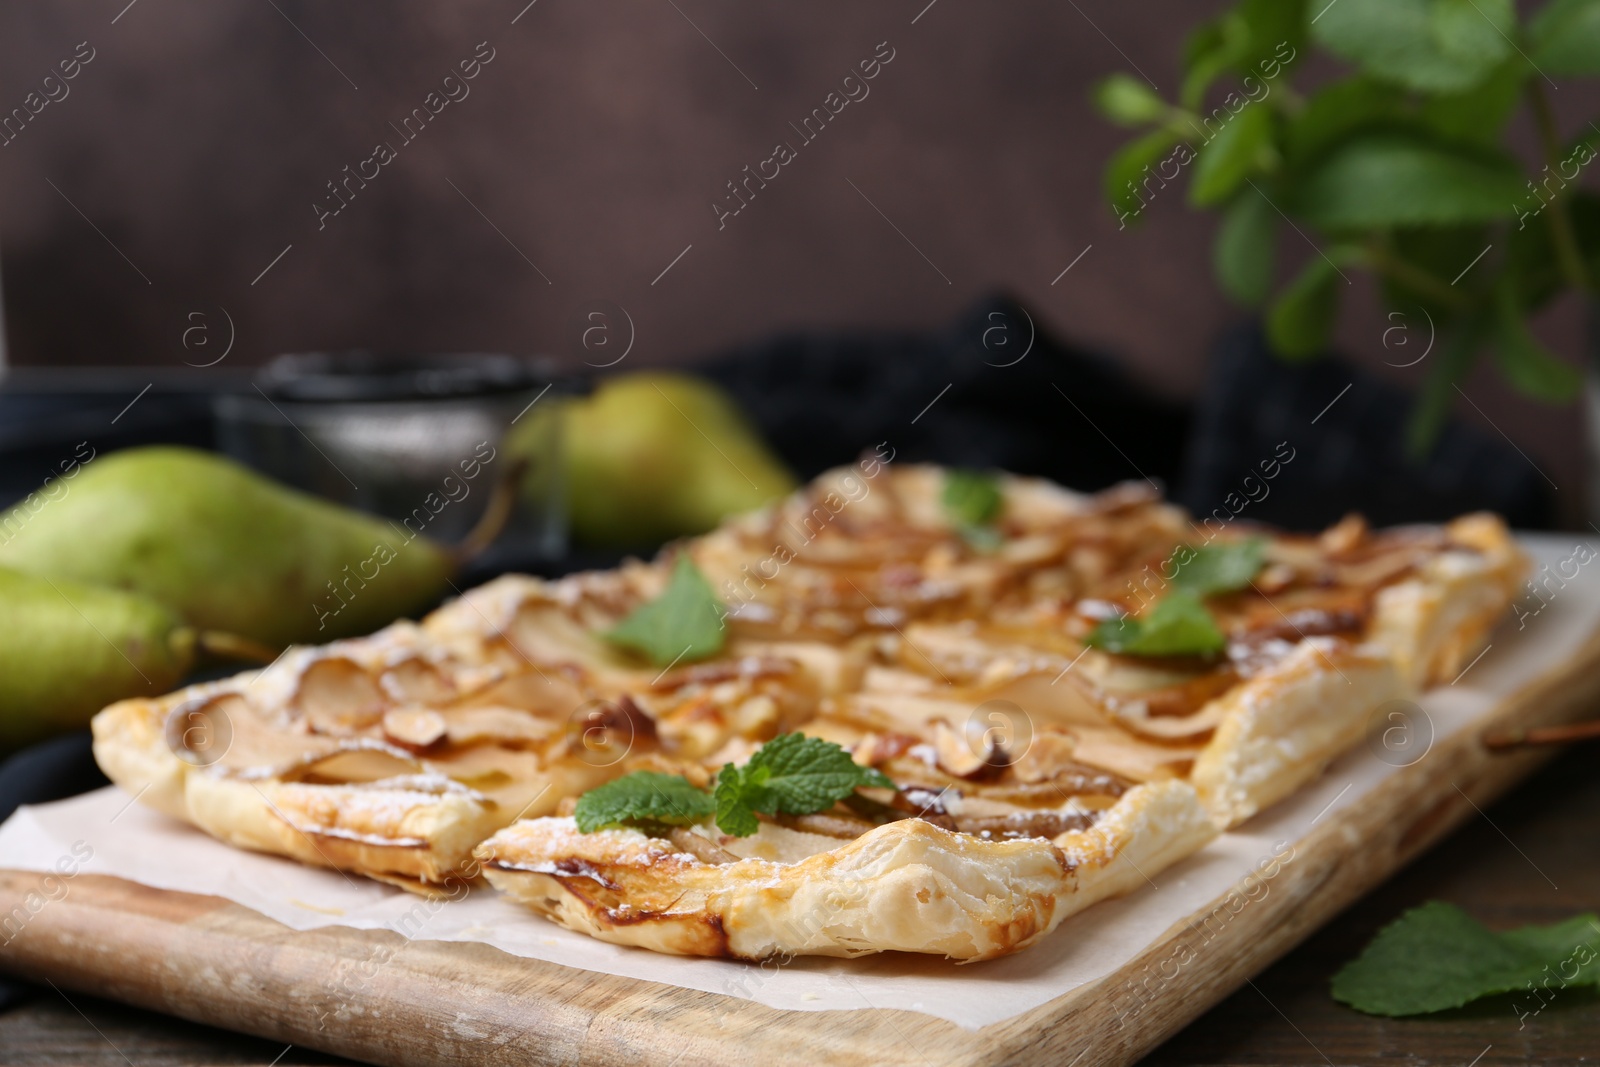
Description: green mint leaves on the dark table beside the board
1333,901,1600,1016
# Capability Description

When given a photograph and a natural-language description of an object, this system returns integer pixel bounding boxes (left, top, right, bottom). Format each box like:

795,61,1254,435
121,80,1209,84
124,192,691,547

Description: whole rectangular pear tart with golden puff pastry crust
94,464,1526,960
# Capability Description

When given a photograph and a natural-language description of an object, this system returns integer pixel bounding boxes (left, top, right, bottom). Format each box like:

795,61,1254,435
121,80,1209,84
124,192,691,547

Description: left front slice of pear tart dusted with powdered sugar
93,566,840,893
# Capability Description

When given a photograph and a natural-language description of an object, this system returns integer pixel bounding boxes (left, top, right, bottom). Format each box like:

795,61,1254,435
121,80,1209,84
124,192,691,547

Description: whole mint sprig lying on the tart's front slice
574,734,894,837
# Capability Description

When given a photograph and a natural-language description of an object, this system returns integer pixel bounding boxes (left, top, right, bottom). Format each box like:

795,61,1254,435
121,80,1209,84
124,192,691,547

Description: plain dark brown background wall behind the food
0,0,1600,518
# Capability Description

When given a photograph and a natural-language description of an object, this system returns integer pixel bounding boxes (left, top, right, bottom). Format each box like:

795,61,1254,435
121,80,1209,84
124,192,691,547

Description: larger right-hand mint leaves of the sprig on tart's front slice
715,734,894,837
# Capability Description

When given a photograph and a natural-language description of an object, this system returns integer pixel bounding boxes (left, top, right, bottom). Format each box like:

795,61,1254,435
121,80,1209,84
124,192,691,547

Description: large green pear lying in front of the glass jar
0,448,456,648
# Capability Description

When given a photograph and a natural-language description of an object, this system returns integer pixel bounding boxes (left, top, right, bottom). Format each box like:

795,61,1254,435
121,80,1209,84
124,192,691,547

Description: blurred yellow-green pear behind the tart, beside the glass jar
562,373,795,545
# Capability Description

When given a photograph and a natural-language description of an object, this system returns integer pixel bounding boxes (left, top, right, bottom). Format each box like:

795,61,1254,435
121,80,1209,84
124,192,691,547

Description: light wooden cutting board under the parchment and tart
0,635,1600,1067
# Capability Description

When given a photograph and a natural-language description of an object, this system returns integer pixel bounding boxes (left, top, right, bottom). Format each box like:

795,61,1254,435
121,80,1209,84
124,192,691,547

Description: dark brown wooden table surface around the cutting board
0,744,1600,1067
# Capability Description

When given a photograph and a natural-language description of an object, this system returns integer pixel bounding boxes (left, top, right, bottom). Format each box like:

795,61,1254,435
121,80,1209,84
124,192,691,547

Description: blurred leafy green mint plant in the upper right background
1094,0,1600,454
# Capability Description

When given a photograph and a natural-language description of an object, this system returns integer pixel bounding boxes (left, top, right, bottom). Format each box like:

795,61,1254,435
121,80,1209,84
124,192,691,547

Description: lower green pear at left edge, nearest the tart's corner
0,568,197,752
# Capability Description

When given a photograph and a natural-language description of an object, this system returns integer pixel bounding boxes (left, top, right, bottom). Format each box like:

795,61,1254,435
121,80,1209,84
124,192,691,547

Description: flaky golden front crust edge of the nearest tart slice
477,782,1216,961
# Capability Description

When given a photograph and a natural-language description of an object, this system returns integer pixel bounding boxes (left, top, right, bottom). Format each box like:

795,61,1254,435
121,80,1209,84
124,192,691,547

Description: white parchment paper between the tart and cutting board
0,536,1600,1030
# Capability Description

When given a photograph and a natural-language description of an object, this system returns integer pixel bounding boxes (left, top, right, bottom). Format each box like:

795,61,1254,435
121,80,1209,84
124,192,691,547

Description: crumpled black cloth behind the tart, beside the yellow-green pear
699,298,1192,490
